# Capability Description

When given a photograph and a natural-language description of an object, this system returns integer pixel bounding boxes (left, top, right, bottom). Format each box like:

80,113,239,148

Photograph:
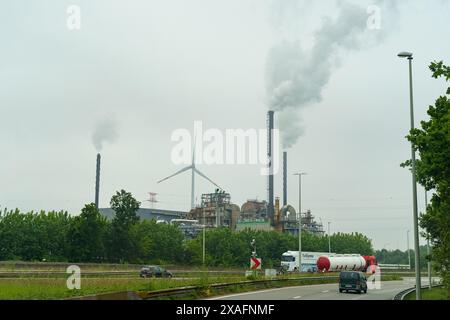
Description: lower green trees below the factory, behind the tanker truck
186,228,373,268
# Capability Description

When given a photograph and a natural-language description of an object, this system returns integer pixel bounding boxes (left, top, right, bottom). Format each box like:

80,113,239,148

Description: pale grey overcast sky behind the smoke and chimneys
0,0,450,249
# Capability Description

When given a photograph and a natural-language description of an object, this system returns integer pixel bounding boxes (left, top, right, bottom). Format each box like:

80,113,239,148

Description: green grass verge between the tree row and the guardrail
0,265,408,300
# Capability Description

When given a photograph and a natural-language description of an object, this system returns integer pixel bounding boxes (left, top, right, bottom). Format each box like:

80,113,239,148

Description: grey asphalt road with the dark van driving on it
209,278,434,301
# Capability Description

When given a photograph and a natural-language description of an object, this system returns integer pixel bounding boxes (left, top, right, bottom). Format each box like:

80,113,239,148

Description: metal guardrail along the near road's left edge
139,276,339,300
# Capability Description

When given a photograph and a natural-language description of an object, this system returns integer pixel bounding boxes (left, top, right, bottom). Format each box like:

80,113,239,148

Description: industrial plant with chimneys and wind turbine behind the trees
99,111,324,238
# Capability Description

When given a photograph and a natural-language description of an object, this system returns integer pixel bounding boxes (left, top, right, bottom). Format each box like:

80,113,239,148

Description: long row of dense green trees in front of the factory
0,190,373,269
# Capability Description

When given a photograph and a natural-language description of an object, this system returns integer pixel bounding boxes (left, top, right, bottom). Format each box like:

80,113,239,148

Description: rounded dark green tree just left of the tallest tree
68,203,107,262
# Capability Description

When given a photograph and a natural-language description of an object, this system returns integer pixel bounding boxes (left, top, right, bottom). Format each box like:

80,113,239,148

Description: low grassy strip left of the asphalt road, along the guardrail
0,273,402,300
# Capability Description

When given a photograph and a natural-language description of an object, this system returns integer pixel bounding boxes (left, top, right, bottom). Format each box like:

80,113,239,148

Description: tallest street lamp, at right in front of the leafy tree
398,52,422,300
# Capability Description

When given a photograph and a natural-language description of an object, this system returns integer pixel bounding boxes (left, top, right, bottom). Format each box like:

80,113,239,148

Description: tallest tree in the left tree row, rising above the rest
108,190,141,262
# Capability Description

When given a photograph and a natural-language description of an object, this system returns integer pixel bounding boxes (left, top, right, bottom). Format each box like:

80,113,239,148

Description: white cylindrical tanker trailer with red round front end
317,254,367,272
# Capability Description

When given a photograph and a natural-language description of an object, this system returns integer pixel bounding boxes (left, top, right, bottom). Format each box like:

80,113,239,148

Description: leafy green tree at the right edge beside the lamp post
402,61,450,297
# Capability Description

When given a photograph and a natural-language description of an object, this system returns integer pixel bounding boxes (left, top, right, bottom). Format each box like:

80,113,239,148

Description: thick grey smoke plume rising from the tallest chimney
266,0,396,149
